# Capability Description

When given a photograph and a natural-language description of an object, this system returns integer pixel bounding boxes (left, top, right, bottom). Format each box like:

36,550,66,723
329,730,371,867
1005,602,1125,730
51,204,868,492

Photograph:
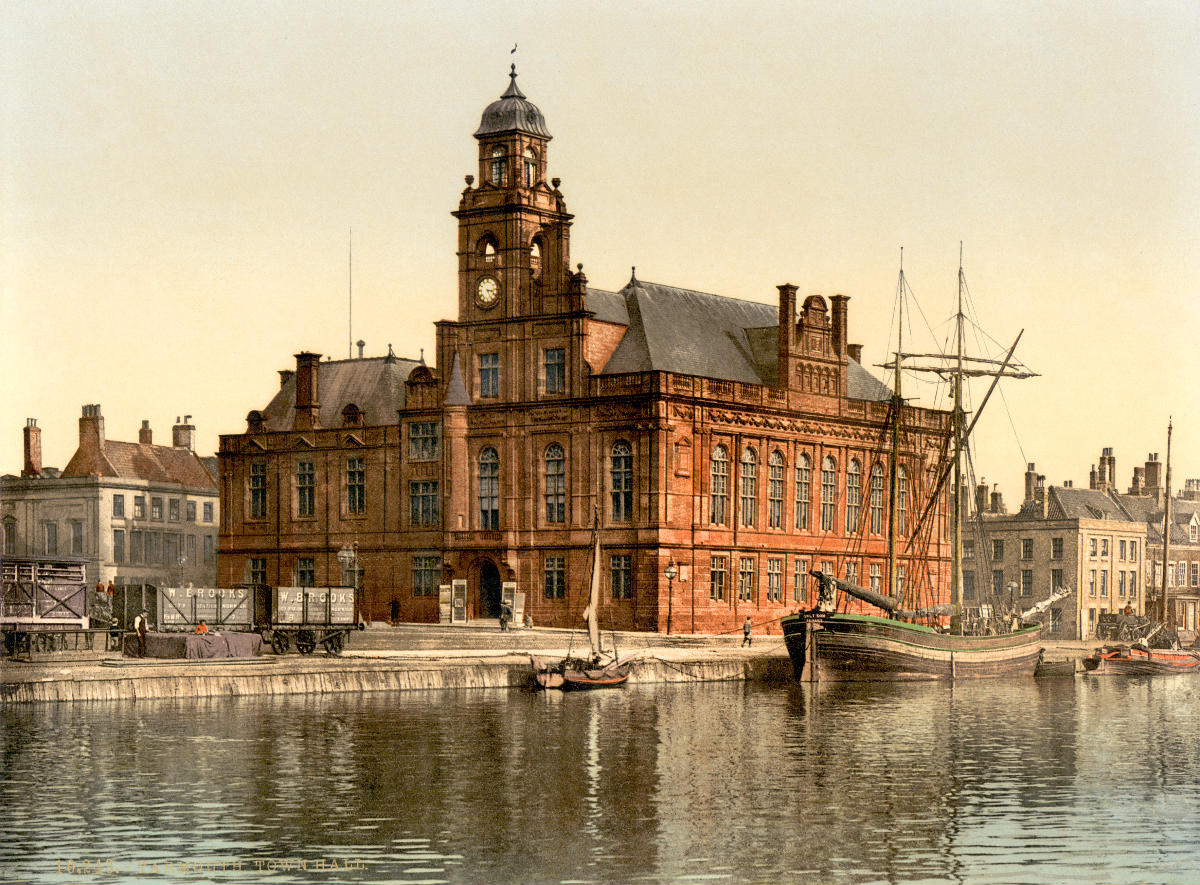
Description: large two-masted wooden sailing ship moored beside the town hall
781,251,1067,681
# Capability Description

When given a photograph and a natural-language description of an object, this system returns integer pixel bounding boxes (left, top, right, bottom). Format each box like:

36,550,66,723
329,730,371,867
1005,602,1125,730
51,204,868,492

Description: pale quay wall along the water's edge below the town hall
0,655,792,706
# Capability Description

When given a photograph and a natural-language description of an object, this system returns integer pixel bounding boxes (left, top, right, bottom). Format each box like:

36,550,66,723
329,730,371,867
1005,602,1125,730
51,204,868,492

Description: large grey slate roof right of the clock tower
587,279,892,401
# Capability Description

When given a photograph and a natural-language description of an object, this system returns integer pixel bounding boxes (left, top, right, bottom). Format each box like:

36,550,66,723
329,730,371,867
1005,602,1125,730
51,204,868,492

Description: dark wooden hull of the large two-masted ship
781,612,1042,682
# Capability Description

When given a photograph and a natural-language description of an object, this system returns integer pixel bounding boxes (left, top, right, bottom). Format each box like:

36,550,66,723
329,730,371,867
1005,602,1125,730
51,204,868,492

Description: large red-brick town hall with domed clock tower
220,72,948,632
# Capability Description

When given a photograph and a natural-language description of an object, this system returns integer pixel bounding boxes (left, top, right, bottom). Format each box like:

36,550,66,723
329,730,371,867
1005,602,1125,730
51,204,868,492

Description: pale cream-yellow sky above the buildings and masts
0,0,1200,498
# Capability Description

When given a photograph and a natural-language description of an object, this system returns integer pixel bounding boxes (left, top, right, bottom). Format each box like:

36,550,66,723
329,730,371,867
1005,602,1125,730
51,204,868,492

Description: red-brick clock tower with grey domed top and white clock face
454,65,571,323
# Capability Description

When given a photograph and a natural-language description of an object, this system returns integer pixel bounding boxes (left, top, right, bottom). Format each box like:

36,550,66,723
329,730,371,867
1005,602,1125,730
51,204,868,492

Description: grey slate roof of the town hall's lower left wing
255,356,421,431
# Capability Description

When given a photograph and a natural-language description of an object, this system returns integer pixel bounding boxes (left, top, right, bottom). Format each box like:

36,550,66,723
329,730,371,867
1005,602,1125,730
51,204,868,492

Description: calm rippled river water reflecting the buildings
0,675,1200,884
